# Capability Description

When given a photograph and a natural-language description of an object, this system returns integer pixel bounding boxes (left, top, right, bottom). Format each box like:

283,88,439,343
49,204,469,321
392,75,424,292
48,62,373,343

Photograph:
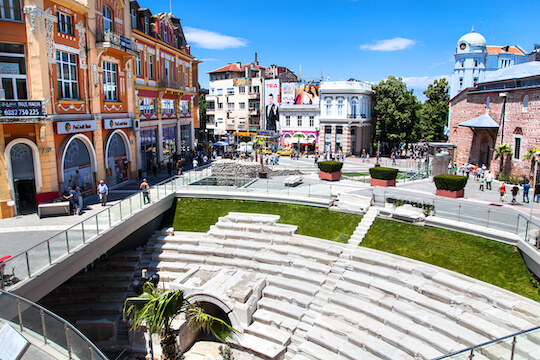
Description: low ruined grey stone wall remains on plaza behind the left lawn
212,160,302,178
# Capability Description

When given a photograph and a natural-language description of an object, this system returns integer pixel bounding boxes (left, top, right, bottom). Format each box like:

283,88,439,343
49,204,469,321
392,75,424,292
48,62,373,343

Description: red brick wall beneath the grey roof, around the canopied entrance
449,88,540,176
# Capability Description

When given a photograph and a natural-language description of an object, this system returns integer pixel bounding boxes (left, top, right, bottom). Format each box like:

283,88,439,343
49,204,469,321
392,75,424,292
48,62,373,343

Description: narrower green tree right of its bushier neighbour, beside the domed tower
420,78,450,141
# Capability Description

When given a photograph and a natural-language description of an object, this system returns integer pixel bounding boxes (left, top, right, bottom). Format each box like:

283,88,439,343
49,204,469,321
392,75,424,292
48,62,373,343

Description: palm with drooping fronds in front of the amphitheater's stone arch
123,283,237,360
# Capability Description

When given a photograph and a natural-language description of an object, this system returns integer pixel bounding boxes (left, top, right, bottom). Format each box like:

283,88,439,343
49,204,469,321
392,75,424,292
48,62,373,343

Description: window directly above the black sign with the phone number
0,43,28,100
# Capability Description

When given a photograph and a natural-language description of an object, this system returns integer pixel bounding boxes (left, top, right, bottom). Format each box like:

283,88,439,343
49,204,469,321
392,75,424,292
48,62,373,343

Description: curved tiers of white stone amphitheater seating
149,213,540,360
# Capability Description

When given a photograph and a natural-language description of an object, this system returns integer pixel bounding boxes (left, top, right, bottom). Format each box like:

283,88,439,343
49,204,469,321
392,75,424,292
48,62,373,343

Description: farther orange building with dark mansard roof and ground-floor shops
130,1,199,172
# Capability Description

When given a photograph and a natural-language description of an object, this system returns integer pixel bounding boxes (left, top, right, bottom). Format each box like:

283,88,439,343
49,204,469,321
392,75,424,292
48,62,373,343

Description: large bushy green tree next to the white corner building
374,76,419,142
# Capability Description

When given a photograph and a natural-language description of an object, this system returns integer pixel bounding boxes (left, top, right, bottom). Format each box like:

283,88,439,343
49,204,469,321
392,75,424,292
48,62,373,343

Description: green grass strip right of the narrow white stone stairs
362,219,540,301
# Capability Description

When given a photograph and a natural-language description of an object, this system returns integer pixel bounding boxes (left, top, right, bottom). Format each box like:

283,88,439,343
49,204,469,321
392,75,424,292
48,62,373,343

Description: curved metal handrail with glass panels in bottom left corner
0,290,108,360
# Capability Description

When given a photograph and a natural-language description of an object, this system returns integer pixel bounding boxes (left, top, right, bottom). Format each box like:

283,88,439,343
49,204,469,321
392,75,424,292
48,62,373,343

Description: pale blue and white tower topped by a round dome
450,28,487,98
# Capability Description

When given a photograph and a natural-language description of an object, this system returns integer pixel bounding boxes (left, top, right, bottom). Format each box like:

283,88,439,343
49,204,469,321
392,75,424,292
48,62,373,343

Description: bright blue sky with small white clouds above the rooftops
139,0,540,99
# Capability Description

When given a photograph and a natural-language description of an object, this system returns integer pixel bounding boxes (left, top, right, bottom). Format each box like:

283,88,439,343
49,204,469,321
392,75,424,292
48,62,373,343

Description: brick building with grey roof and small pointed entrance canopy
449,61,540,177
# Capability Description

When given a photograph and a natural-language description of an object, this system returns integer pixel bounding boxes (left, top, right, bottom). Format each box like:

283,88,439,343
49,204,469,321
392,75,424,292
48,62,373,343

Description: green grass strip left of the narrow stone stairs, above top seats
162,198,362,242
